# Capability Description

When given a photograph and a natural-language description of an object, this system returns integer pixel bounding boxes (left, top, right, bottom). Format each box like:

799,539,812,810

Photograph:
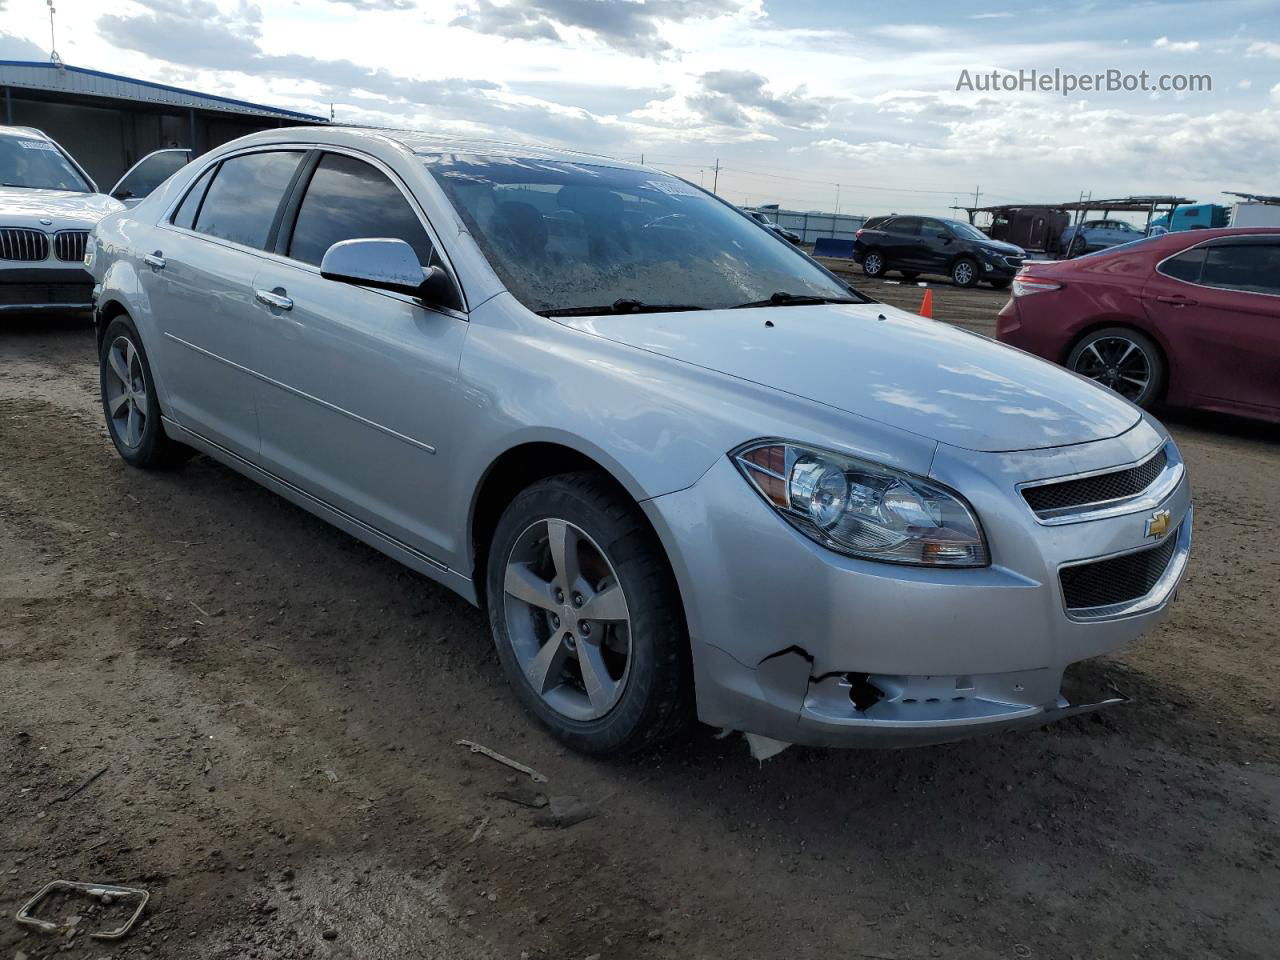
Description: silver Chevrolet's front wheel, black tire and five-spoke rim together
486,472,692,754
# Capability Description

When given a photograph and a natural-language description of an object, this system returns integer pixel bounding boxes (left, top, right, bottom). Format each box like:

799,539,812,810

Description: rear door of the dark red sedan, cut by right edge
1143,236,1280,411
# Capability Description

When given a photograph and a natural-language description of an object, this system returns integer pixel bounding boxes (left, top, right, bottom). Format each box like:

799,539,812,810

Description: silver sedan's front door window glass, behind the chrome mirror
288,154,431,266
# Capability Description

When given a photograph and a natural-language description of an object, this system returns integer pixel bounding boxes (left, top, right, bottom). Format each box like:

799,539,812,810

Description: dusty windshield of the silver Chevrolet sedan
425,155,856,312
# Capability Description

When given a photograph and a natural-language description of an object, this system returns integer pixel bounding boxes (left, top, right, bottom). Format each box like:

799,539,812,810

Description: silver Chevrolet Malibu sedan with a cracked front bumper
88,129,1192,754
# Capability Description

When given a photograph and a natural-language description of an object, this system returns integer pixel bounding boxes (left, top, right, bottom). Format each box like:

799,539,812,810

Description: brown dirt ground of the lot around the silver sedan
0,283,1280,960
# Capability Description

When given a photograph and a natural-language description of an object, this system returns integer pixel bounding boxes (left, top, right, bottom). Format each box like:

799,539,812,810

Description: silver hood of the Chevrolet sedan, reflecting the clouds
558,303,1140,452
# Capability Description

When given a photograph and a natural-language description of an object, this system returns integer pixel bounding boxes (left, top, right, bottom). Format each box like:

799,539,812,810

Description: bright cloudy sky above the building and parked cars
0,0,1280,214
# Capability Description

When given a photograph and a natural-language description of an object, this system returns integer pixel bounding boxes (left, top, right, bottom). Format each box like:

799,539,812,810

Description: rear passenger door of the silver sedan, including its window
147,150,303,458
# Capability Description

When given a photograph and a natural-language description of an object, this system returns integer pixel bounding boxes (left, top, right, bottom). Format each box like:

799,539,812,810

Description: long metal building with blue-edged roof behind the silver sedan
0,60,328,189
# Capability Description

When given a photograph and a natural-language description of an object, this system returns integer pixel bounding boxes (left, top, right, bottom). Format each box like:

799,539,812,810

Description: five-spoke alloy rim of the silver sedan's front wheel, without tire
503,517,631,722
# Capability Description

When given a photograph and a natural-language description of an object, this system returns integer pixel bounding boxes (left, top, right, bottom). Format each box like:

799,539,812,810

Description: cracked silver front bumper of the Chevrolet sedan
645,420,1192,746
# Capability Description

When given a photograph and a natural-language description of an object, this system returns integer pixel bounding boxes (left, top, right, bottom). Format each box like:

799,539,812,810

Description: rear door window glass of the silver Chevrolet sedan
195,151,302,250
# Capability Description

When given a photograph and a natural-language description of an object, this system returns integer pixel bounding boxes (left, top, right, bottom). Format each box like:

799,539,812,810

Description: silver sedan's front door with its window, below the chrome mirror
252,152,467,556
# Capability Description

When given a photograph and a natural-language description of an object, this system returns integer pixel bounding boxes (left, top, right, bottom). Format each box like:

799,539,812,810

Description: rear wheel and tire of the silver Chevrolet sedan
97,314,195,468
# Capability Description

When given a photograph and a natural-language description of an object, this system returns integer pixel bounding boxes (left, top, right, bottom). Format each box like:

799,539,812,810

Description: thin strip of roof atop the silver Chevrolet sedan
220,125,650,170
